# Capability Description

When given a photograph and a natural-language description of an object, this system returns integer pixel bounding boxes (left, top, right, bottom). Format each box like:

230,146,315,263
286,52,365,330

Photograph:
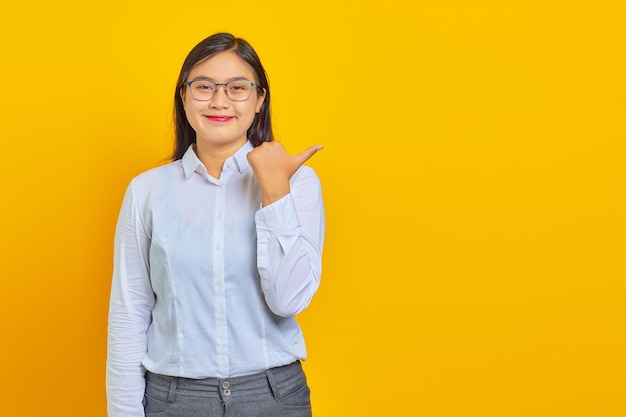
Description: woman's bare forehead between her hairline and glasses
189,51,256,81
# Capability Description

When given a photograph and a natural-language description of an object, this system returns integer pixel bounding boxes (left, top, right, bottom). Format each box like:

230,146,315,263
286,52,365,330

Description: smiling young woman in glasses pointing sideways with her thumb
107,33,325,417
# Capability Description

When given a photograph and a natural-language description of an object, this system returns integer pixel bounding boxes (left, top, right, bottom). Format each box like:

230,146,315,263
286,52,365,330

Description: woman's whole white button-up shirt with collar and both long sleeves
107,143,325,417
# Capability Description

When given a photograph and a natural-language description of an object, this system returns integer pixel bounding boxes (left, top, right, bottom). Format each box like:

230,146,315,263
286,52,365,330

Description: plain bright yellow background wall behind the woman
0,0,626,417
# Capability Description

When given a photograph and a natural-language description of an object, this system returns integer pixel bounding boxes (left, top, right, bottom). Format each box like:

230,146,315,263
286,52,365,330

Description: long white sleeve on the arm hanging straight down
106,183,154,417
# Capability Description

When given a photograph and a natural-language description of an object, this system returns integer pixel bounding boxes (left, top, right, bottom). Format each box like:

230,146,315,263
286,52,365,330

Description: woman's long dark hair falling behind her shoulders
172,33,274,161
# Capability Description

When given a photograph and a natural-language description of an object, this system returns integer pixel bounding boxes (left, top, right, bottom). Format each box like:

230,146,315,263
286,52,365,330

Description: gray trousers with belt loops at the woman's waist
144,361,311,417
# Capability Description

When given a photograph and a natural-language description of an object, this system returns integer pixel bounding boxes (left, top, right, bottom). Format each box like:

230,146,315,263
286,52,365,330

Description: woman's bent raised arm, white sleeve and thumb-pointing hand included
248,142,325,317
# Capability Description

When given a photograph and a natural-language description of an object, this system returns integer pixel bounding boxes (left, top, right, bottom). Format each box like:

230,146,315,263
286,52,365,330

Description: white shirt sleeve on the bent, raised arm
255,166,325,317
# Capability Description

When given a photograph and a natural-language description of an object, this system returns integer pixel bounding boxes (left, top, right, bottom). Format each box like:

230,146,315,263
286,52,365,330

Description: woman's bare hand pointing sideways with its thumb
248,141,322,206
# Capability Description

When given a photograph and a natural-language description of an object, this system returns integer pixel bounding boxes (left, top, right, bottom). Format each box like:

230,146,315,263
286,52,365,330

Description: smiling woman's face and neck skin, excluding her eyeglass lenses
181,51,265,147
